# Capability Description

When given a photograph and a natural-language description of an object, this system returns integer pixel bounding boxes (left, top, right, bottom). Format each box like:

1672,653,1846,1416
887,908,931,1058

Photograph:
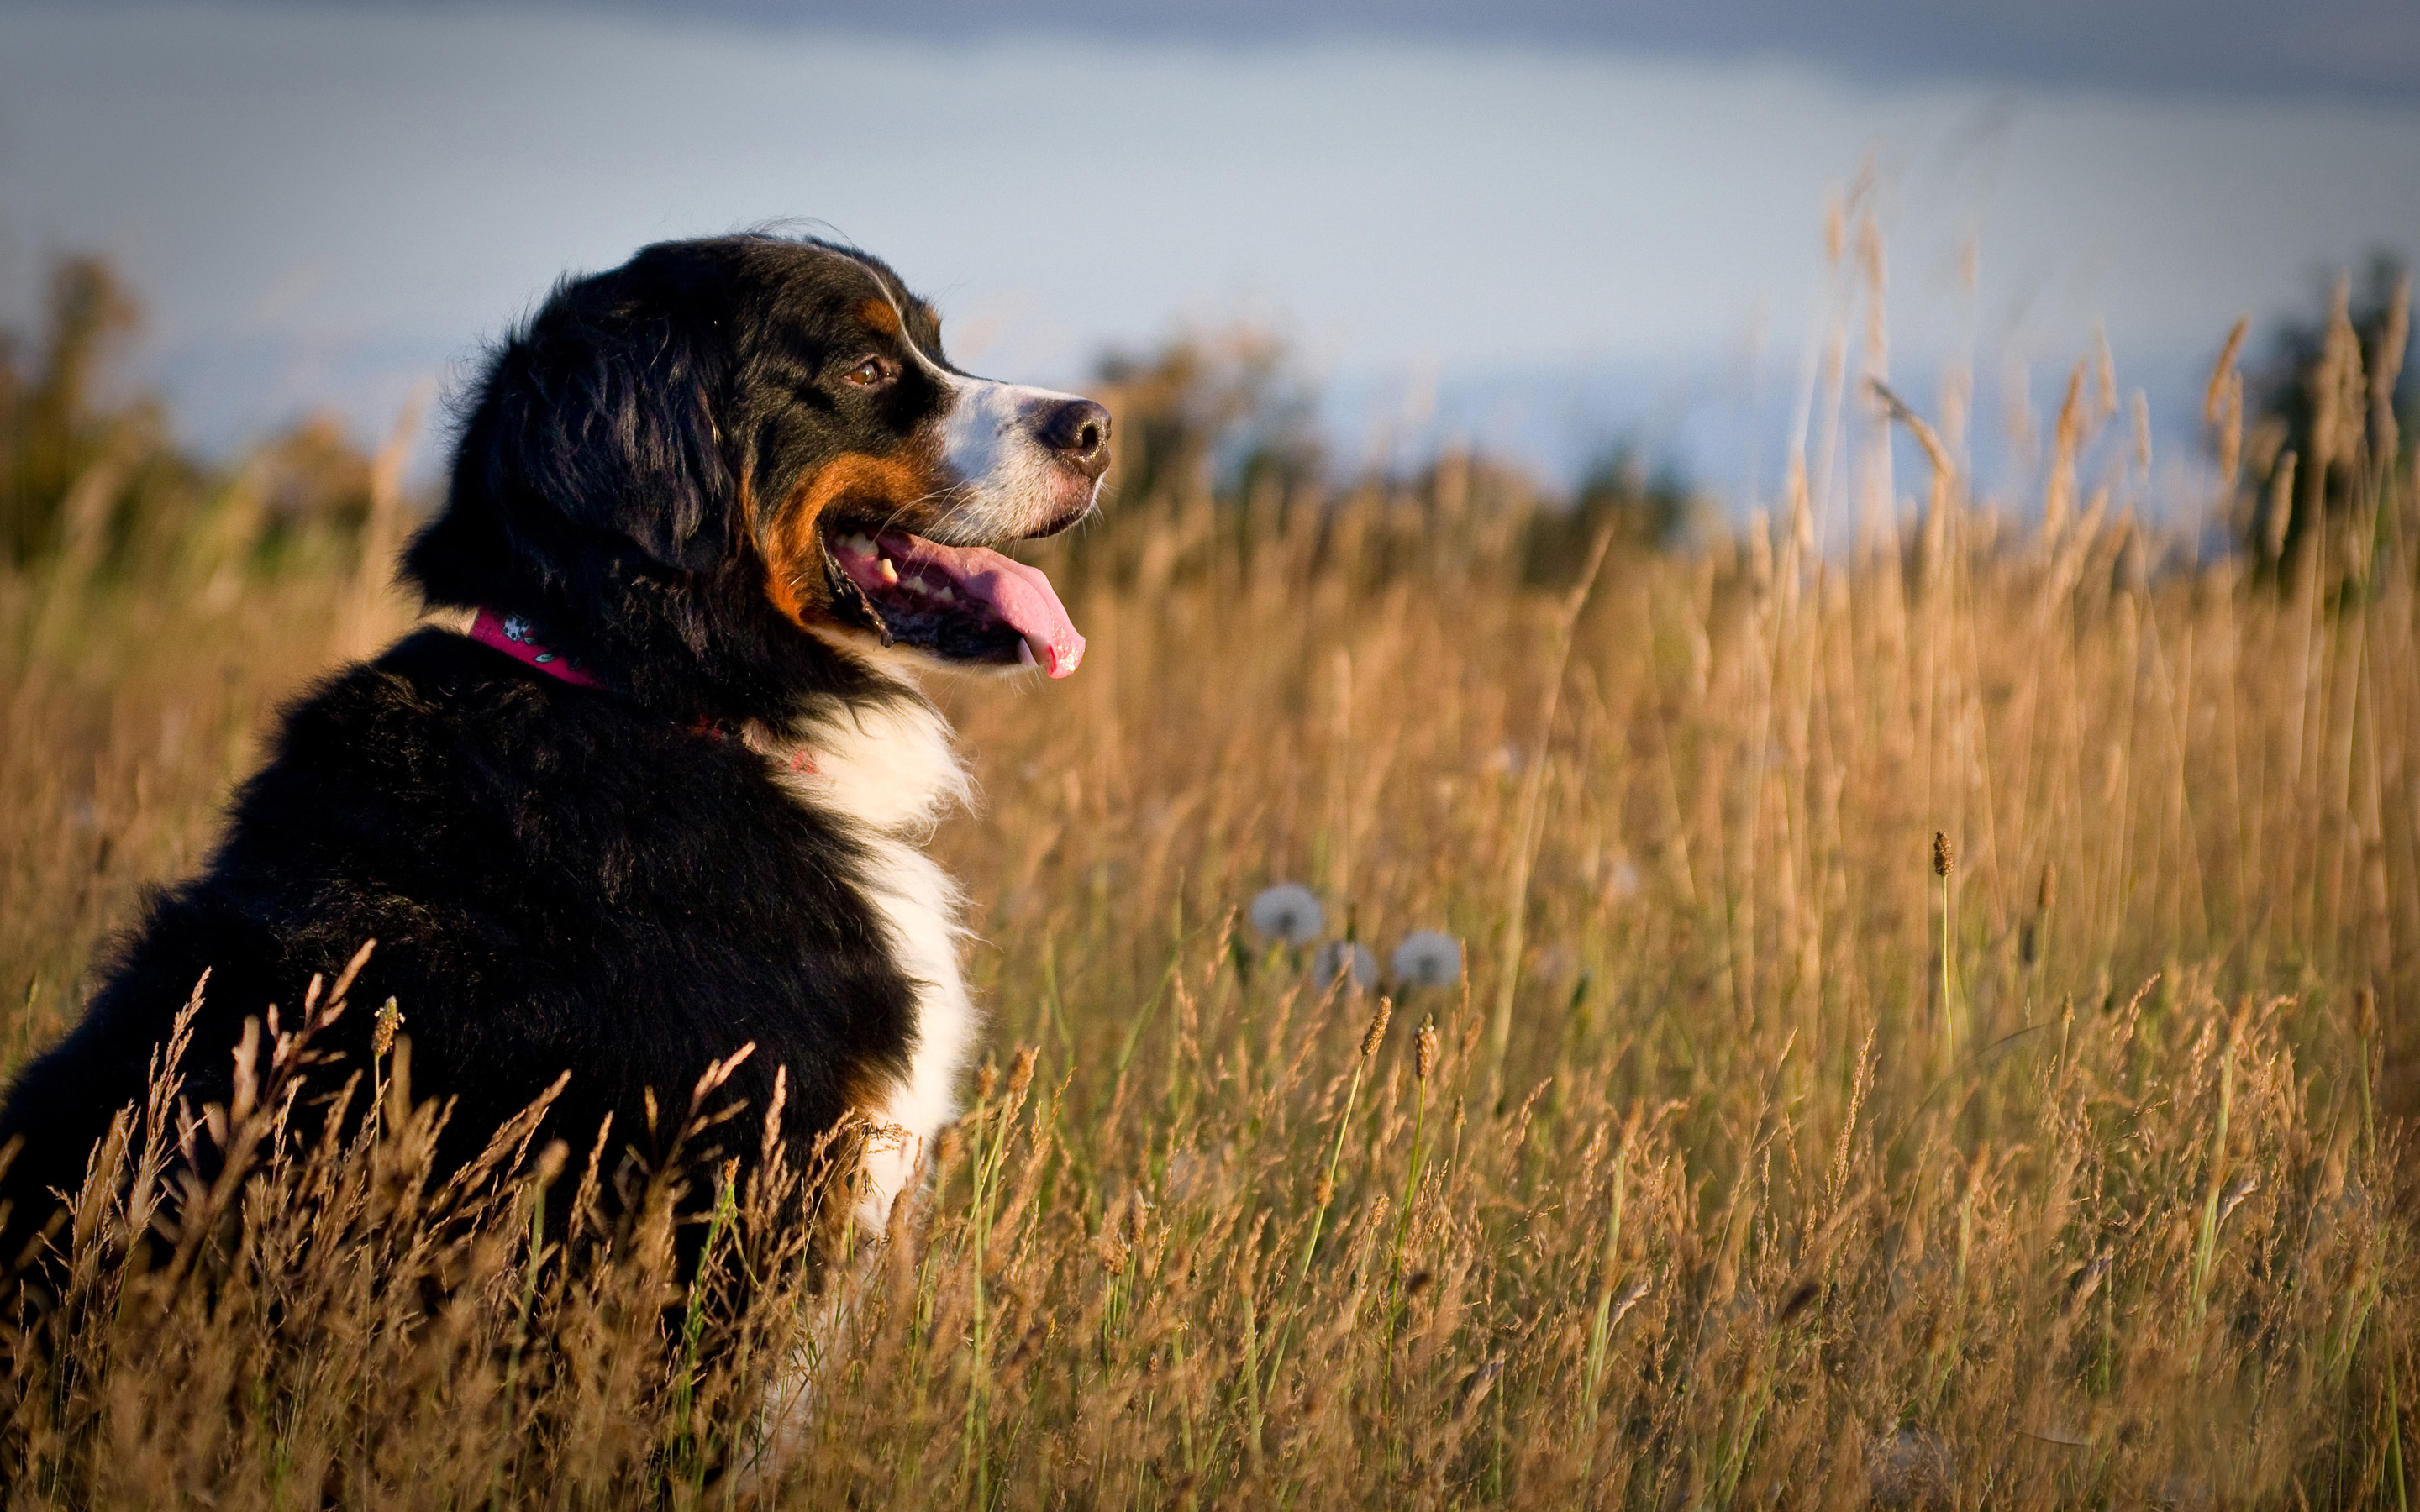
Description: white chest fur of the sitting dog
750,695,980,1231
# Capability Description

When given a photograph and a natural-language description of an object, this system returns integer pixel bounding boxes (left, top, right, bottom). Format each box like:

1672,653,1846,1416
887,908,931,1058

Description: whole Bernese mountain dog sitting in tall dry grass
0,234,1108,1263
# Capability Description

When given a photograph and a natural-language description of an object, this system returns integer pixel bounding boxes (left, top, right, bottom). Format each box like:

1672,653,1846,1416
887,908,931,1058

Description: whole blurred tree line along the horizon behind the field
13,244,2420,585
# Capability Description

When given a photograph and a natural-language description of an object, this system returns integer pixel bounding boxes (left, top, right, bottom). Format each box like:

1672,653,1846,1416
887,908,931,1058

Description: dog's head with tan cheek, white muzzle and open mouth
404,234,1108,696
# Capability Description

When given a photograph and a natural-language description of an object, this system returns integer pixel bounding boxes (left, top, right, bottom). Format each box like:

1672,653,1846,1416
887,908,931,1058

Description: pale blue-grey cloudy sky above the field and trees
0,0,2420,501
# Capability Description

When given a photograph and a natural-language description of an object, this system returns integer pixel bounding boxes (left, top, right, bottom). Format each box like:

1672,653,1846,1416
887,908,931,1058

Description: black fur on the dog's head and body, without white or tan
0,237,1106,1256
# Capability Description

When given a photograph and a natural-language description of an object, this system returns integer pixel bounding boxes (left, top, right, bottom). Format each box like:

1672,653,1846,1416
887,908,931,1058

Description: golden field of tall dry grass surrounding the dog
0,242,2420,1509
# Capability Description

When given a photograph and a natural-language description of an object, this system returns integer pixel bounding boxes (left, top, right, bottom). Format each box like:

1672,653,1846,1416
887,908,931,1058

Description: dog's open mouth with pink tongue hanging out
823,522,1084,677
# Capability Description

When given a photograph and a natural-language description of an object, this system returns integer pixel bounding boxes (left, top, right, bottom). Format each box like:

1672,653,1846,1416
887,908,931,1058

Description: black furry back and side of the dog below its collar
0,629,915,1253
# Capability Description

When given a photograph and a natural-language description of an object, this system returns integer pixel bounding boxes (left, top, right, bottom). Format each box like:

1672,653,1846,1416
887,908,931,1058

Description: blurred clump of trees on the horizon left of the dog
0,256,375,571
